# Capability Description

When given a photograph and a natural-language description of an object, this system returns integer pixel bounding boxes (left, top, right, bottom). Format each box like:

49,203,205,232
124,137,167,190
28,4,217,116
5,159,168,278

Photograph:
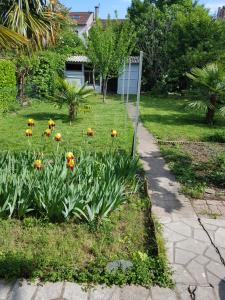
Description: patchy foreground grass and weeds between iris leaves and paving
0,195,172,286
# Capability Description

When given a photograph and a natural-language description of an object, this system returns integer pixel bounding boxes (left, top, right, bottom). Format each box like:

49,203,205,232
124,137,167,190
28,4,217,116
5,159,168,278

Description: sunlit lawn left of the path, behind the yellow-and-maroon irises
0,96,132,152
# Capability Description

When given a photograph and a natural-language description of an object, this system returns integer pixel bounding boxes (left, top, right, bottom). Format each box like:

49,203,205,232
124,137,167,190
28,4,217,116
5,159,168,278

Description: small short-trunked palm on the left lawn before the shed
54,79,94,121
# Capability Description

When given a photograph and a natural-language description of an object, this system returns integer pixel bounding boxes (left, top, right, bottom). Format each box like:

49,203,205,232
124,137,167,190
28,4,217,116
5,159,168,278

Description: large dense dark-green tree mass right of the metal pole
128,0,225,91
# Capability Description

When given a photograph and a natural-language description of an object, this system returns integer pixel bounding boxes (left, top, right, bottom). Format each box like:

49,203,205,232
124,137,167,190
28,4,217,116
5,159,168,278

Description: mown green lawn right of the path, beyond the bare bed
141,95,225,141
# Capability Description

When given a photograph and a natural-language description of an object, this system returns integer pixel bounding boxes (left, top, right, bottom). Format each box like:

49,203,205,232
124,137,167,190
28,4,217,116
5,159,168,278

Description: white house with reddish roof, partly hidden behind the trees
69,6,99,41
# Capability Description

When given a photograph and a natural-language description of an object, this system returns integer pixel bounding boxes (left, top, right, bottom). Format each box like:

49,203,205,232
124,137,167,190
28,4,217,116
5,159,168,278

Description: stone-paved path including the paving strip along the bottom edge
0,105,225,300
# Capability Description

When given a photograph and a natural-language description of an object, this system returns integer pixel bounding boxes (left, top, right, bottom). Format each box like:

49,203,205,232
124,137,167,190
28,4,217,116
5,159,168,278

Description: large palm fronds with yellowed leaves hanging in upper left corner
0,0,63,49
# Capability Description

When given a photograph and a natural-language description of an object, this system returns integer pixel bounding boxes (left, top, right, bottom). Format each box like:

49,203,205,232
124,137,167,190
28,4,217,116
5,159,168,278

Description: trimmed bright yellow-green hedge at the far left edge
0,59,16,112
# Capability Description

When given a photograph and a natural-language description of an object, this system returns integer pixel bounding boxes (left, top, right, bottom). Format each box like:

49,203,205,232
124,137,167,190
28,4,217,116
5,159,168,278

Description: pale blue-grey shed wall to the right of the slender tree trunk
117,64,139,95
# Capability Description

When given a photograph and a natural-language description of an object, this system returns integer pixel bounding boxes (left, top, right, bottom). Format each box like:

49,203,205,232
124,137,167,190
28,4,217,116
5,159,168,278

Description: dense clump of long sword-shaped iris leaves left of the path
0,152,138,222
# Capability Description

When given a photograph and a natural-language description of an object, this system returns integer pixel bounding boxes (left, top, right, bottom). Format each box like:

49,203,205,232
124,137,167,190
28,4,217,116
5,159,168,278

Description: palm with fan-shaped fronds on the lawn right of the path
186,63,225,125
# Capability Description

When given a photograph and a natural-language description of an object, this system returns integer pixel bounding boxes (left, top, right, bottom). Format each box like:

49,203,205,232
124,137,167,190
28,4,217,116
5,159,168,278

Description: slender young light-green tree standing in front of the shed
86,19,135,102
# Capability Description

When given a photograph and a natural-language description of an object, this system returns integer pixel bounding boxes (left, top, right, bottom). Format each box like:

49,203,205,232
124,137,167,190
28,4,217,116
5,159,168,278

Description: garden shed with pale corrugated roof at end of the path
65,55,139,95
